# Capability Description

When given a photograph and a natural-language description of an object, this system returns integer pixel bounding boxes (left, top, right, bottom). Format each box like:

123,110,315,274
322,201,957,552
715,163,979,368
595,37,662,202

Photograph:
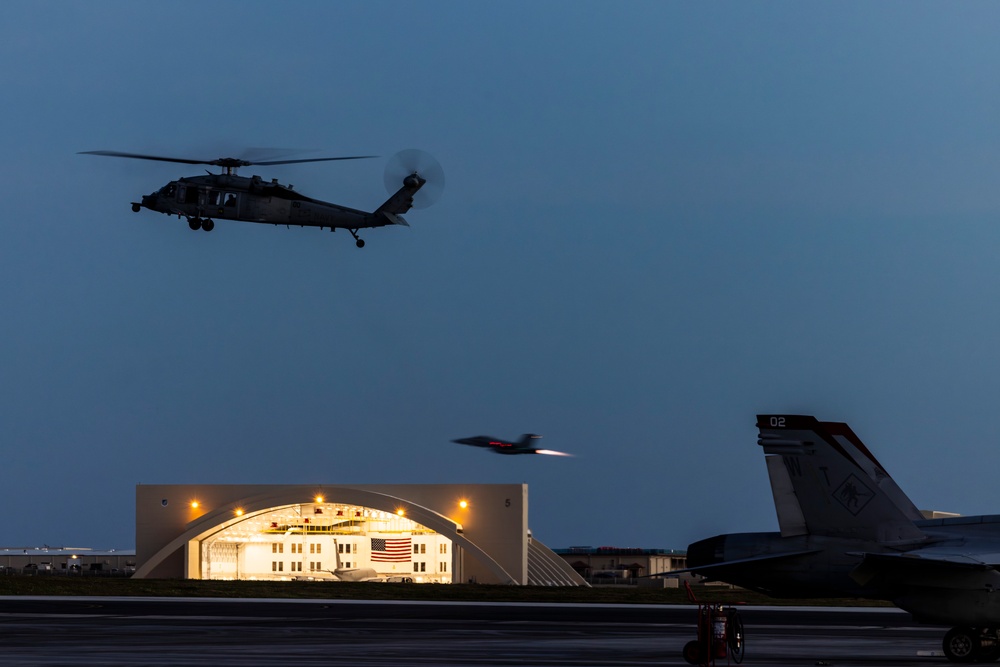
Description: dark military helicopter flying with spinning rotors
80,149,444,248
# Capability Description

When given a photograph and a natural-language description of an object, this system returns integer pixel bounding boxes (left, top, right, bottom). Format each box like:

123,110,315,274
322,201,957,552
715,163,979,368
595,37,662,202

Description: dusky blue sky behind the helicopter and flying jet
0,1,1000,548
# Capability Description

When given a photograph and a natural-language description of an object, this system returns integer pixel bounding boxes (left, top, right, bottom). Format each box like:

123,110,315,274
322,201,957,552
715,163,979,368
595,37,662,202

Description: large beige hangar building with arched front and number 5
133,484,587,586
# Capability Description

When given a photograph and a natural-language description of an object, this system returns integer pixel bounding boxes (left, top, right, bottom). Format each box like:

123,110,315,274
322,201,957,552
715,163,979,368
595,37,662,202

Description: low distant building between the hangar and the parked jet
554,547,687,581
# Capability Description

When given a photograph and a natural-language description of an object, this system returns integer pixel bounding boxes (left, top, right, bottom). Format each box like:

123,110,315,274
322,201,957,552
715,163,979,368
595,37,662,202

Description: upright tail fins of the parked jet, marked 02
757,415,926,544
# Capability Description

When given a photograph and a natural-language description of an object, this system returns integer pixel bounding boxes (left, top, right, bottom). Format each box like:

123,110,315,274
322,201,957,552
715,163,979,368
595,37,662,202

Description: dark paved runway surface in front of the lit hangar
0,597,949,667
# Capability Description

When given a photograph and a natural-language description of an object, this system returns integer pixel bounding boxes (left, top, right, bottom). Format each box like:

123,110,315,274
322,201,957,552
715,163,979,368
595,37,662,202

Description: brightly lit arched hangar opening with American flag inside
200,501,454,584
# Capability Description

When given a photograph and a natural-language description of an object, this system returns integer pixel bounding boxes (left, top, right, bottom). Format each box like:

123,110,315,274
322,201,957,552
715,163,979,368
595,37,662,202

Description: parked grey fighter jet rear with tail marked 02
687,415,1000,662
